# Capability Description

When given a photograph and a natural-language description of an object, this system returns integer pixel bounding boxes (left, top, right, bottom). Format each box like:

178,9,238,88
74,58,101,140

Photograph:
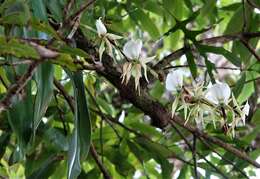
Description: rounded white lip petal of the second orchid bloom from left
123,40,143,60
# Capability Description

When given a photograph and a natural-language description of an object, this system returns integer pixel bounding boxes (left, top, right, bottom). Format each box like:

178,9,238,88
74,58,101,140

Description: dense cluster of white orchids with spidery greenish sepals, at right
166,70,250,137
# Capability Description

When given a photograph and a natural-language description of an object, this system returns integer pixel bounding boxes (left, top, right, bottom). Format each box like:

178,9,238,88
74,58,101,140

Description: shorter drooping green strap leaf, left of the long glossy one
33,63,54,133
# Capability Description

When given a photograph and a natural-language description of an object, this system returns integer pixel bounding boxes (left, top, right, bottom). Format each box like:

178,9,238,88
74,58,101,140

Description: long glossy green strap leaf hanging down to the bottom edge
67,72,91,179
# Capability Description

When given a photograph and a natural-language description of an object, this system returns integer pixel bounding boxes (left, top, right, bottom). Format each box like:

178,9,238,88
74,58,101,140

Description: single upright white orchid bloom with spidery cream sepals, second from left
121,39,155,93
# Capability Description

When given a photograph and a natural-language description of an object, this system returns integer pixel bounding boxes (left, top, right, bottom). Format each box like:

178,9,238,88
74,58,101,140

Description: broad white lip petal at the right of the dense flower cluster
205,83,231,105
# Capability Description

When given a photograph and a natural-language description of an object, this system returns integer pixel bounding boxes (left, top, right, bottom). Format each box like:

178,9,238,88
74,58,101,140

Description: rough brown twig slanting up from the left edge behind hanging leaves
0,61,40,114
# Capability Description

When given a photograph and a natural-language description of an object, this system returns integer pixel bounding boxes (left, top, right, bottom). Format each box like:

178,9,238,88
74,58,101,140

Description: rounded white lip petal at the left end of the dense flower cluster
165,70,183,92
